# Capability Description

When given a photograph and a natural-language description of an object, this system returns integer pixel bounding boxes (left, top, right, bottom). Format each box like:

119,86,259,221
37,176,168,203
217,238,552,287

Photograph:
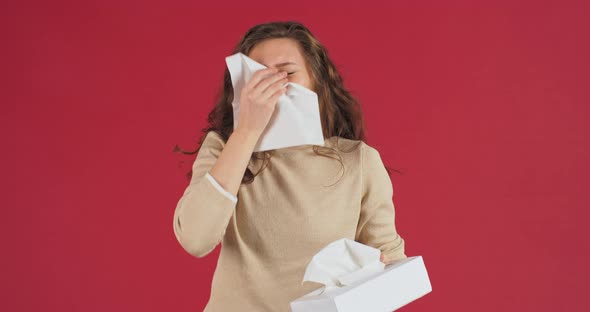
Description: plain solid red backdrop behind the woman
5,1,590,311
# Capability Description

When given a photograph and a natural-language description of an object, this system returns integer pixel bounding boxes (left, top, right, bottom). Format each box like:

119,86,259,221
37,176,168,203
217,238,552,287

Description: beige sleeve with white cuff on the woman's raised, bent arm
174,131,237,258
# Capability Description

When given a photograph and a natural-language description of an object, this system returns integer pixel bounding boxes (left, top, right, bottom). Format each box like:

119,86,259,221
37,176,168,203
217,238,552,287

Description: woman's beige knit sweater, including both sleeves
174,131,407,312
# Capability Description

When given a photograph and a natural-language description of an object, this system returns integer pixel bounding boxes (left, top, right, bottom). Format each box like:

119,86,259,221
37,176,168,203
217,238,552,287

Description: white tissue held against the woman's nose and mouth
225,52,324,152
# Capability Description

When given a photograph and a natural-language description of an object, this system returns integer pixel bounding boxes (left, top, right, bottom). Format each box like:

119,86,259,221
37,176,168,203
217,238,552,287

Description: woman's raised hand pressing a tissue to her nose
236,68,288,136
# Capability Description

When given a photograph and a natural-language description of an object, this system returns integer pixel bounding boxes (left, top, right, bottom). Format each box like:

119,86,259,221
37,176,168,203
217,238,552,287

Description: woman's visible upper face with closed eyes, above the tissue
248,38,315,91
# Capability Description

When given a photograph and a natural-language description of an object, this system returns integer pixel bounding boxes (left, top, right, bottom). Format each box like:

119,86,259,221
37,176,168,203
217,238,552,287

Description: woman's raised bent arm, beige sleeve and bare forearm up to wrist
174,131,256,257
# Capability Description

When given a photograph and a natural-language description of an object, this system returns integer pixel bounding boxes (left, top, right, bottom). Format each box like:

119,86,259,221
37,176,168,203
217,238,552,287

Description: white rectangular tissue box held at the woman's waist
291,256,432,312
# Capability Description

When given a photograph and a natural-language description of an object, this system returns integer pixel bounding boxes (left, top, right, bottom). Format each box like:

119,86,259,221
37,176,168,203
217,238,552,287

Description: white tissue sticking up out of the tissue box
302,238,385,295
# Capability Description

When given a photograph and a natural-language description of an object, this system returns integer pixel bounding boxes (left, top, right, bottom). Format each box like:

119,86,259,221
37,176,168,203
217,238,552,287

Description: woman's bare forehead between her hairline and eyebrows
248,38,303,67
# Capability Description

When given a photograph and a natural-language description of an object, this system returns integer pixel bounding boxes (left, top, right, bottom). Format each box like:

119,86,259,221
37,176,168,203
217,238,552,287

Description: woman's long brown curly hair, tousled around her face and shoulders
174,21,399,183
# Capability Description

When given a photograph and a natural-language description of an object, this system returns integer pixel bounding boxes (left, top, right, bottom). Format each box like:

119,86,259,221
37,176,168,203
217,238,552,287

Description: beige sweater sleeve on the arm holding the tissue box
356,142,407,260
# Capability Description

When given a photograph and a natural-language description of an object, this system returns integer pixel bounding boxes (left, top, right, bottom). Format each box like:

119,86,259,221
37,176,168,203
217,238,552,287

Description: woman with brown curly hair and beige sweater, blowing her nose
174,22,407,312
